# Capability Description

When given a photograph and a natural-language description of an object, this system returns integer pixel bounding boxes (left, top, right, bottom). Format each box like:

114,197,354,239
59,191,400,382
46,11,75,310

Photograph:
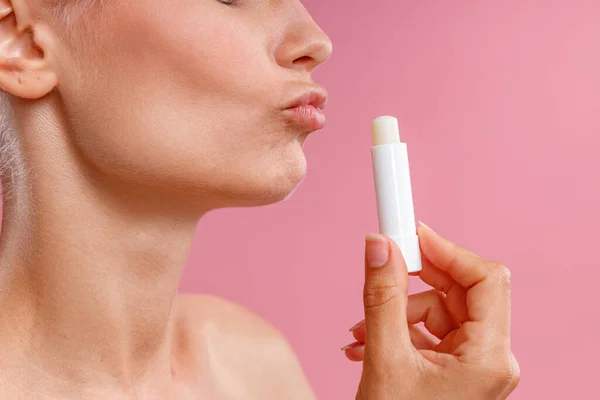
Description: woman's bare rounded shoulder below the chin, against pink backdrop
177,295,315,400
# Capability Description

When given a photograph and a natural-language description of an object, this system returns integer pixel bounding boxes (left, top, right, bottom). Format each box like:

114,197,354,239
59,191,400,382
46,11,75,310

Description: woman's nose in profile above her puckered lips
275,6,333,72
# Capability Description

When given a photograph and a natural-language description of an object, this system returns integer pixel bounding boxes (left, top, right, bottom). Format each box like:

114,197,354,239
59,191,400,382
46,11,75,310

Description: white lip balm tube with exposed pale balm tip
371,116,422,272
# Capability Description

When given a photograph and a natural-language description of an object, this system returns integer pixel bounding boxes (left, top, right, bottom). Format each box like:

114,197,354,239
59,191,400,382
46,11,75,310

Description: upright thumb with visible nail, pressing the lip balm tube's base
363,234,414,367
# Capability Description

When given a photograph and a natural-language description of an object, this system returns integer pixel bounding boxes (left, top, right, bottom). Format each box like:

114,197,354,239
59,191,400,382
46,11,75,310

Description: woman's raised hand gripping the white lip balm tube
343,225,520,400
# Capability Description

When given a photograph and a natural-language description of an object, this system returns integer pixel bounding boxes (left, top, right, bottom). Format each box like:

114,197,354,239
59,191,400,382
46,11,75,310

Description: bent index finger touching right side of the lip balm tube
419,224,510,338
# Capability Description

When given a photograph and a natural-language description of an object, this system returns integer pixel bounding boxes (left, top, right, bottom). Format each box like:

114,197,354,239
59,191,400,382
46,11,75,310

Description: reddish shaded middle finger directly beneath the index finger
419,257,469,324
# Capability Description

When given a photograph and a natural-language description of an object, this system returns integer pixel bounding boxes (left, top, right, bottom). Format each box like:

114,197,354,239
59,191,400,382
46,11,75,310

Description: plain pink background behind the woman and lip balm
182,0,600,400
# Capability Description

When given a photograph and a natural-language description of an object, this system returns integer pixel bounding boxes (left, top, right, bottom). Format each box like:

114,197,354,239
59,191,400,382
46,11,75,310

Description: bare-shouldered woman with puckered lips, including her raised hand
0,0,518,399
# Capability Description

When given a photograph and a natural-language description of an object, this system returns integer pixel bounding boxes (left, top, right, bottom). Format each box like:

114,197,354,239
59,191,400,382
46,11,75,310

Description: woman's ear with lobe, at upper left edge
0,0,58,99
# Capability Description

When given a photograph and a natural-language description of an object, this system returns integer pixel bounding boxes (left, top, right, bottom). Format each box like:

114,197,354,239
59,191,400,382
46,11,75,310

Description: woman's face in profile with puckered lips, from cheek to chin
48,0,331,207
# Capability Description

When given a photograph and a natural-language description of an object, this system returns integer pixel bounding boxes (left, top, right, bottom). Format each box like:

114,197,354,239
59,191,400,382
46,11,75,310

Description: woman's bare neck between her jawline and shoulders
0,98,204,387
